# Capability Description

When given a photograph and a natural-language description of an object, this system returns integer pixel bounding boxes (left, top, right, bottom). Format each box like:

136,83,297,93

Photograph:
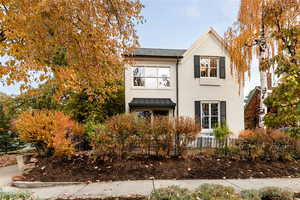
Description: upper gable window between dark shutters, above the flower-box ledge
200,57,219,78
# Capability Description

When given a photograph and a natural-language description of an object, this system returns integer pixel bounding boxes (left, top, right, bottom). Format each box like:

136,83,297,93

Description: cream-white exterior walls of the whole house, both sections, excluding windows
125,32,244,136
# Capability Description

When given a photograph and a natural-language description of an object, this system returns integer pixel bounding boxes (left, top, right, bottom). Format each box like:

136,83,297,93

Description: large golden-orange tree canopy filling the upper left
0,0,143,101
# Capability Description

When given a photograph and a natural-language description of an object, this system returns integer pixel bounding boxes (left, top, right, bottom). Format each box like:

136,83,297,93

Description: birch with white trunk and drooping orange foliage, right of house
225,0,300,127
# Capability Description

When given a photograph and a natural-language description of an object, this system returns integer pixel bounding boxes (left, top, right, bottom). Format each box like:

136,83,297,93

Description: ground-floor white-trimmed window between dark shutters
201,102,220,129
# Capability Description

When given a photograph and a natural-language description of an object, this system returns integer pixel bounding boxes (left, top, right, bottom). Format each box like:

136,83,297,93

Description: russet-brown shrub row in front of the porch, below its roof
92,114,199,158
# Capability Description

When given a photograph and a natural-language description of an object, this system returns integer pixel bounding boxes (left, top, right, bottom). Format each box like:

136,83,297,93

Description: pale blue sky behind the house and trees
0,0,259,95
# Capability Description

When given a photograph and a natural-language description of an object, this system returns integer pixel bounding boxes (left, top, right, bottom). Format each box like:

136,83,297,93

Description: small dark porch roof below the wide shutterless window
129,98,176,108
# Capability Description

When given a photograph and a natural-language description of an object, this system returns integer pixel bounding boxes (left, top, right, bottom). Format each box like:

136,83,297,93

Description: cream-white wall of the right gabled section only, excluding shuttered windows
179,33,244,136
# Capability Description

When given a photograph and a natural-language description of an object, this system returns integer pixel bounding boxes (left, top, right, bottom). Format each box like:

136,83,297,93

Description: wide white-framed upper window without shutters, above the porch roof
133,67,171,89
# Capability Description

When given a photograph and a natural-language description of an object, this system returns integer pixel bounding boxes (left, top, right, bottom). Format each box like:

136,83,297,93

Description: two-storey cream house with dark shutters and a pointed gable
125,28,244,135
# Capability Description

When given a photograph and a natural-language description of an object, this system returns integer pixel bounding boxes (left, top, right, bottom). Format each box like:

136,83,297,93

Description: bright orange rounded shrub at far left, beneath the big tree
13,110,84,156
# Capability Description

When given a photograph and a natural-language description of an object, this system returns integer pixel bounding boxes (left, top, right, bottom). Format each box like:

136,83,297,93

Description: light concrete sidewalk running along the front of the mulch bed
3,178,300,199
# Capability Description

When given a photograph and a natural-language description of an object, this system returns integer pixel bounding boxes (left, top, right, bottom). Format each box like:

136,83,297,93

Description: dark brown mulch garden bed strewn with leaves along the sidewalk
24,154,300,182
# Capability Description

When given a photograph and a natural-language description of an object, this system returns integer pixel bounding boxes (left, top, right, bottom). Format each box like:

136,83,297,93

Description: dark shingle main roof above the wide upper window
133,48,186,58
